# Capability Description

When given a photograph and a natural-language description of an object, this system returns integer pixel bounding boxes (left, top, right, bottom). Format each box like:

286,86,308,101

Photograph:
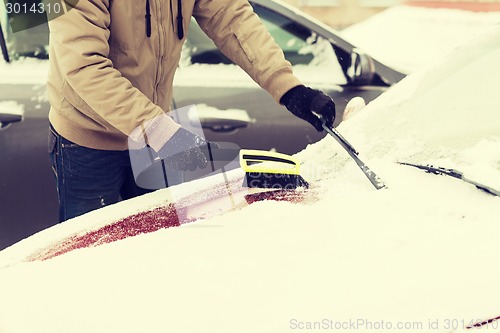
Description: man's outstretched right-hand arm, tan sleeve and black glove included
193,0,342,131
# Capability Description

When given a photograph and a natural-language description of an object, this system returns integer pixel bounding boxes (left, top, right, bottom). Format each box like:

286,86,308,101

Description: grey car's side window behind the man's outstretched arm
183,5,334,66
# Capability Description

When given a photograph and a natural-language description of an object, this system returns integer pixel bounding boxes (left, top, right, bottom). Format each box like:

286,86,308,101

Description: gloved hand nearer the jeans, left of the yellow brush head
158,127,218,171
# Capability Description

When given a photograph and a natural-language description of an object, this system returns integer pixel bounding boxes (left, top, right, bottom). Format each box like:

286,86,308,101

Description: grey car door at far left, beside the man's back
0,13,58,250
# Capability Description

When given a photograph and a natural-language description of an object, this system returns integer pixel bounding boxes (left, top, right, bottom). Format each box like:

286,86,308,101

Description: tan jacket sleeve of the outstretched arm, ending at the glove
193,0,301,103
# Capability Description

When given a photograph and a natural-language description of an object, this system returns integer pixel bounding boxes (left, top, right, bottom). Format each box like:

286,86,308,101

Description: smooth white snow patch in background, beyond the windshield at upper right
342,6,500,73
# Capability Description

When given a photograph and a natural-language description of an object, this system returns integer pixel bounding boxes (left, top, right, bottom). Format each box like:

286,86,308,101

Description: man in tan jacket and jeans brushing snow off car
48,0,335,221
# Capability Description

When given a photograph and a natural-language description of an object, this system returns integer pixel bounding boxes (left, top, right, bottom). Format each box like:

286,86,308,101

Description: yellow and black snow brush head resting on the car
240,149,309,190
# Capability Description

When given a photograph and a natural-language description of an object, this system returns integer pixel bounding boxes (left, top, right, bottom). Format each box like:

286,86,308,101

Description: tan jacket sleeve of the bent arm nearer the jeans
49,0,179,150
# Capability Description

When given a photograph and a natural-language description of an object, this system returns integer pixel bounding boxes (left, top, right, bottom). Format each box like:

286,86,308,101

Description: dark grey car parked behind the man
0,0,404,249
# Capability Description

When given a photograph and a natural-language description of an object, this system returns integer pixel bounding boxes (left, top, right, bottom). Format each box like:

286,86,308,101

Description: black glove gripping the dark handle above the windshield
280,86,335,132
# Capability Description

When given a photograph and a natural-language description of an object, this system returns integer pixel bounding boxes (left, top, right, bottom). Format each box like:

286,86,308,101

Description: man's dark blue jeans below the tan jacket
49,127,151,222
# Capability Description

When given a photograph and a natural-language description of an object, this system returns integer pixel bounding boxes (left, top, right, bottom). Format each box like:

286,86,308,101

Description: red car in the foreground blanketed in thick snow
0,26,500,333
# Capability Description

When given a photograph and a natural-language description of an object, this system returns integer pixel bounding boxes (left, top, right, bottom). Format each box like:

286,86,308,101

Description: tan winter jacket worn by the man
48,0,300,150
